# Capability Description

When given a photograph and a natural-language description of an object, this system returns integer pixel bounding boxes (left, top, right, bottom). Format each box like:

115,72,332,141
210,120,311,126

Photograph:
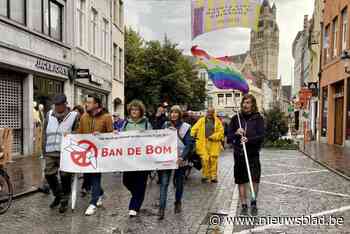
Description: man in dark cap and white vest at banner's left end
43,94,79,213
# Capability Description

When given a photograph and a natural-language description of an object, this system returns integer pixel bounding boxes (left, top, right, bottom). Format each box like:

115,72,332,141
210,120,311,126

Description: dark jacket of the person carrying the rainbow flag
227,113,265,155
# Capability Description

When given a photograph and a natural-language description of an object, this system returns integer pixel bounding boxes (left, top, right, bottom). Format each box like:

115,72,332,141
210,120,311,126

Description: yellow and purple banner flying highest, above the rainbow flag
191,0,261,39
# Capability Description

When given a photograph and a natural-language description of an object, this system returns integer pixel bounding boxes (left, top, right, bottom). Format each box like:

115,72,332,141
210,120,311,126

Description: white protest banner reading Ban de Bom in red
60,129,177,173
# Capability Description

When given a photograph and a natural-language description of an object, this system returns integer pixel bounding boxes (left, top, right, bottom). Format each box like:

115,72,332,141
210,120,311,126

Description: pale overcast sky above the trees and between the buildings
124,0,314,84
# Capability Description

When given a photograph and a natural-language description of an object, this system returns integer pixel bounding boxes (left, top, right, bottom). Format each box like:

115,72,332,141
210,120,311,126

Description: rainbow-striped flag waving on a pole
191,46,249,93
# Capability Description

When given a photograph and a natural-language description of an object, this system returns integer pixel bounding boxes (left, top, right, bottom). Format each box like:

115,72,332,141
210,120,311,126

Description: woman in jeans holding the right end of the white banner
159,106,194,220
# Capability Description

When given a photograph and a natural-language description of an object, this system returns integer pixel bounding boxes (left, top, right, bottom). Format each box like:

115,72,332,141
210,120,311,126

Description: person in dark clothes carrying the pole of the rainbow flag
227,94,265,216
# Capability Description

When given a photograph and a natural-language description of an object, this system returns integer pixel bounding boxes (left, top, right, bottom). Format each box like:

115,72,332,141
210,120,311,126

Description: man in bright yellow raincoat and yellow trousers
191,107,224,183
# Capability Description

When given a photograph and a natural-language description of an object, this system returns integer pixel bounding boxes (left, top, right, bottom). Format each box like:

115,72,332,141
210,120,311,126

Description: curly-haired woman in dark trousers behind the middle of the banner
122,100,152,218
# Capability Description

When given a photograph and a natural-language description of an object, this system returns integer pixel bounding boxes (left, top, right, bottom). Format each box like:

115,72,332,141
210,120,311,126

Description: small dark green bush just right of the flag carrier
264,106,288,142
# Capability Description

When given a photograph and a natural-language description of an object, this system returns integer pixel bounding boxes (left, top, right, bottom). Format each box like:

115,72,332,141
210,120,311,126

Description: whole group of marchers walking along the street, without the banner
43,94,264,220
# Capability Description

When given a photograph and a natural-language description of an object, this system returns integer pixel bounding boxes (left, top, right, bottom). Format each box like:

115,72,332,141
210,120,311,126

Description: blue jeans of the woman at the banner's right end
160,167,185,209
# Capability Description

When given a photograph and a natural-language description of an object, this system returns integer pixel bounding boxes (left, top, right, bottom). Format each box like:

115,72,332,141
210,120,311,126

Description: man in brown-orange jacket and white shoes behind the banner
79,96,113,215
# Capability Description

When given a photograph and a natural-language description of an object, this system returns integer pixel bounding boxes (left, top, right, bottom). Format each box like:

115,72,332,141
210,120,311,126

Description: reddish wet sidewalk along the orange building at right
302,142,350,179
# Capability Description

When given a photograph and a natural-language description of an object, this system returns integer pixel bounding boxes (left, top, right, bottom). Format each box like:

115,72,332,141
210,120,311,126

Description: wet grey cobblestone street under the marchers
0,150,350,234
